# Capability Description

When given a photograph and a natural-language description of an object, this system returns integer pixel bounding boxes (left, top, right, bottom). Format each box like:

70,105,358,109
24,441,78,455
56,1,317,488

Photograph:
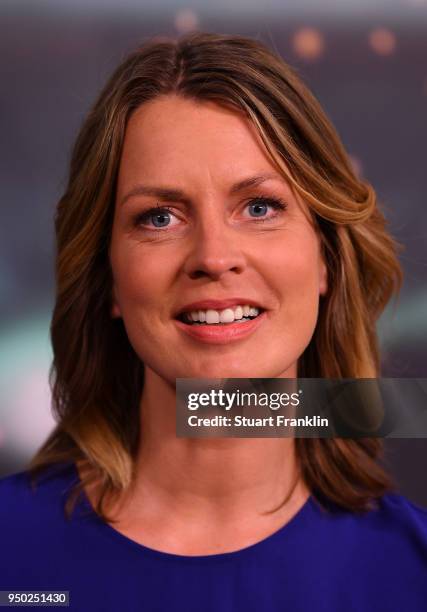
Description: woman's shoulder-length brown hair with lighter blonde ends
29,32,401,519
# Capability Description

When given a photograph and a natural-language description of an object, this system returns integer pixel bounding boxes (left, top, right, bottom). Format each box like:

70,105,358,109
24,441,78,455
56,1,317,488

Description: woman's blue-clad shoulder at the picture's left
0,464,106,590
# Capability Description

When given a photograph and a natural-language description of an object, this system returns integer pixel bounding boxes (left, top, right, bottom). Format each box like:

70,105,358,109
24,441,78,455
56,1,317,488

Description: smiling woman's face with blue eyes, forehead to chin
110,96,327,384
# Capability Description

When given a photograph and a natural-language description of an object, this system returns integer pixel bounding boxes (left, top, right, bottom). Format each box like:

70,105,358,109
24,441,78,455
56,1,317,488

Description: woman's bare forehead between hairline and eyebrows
119,96,277,188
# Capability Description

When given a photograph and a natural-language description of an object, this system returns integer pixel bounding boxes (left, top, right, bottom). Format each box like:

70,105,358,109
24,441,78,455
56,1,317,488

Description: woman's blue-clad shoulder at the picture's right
303,493,427,611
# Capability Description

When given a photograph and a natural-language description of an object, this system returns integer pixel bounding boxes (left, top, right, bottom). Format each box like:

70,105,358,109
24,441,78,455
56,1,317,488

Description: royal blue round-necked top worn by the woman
0,464,427,612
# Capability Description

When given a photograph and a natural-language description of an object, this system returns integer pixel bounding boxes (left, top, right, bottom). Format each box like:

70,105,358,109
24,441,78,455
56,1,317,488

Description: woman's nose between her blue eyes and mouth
184,218,246,280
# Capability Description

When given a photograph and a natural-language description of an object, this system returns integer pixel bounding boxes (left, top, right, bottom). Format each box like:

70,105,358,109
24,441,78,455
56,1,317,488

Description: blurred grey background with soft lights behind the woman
0,0,427,507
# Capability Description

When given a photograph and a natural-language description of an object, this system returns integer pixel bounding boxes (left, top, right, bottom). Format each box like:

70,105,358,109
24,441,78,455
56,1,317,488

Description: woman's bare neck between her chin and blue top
133,368,308,519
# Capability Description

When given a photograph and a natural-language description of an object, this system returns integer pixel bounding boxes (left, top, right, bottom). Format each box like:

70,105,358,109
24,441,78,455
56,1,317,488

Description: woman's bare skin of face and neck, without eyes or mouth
100,96,327,555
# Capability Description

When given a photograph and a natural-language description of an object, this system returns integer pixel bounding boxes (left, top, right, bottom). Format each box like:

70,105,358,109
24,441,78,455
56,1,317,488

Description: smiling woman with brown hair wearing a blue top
0,33,427,612
